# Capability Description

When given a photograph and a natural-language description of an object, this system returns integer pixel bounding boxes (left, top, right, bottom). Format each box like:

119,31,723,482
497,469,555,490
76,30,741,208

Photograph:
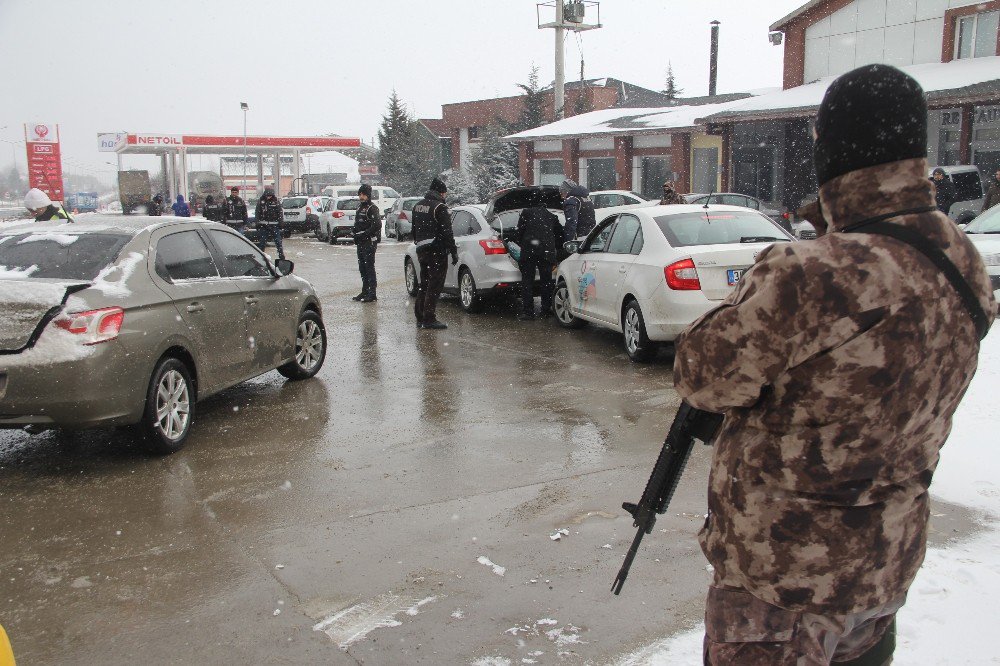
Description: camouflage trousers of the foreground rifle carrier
704,584,905,666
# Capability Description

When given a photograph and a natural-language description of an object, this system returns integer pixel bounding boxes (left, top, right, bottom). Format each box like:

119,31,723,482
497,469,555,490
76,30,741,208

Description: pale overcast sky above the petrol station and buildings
0,0,804,182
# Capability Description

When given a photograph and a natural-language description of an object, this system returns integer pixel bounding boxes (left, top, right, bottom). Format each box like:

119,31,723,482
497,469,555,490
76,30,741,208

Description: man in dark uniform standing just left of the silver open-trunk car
413,178,458,329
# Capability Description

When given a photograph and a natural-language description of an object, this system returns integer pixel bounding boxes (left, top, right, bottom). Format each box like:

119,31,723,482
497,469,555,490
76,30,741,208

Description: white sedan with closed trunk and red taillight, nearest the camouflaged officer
552,205,794,362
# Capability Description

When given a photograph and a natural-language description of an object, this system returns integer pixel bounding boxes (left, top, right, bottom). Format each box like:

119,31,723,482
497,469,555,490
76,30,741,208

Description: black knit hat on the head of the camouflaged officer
815,65,927,186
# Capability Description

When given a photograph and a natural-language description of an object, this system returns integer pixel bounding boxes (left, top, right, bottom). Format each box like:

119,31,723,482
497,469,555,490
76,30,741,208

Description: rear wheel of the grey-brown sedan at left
139,358,194,454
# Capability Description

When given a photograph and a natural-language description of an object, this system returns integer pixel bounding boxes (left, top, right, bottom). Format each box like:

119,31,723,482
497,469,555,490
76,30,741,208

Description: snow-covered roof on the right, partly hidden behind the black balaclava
697,56,1000,123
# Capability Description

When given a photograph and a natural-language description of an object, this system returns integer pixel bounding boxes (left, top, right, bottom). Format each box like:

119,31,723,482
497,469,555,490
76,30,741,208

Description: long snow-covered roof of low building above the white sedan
506,99,756,142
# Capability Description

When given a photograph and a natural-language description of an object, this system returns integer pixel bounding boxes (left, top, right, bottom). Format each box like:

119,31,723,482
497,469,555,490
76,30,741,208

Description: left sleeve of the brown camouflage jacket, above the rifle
674,243,884,412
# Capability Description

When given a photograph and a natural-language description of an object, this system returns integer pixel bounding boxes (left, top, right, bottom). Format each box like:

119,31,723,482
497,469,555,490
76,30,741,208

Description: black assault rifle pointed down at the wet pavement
611,402,723,594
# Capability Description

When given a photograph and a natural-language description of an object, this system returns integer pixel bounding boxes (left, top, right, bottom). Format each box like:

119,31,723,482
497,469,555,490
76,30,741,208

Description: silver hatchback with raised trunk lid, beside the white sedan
403,187,565,312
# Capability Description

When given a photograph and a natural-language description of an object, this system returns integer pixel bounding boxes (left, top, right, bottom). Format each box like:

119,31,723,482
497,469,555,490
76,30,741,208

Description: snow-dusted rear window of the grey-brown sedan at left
0,233,132,280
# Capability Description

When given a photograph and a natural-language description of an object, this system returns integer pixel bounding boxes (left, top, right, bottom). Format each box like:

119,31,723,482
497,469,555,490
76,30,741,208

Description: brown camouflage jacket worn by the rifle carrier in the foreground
674,159,996,613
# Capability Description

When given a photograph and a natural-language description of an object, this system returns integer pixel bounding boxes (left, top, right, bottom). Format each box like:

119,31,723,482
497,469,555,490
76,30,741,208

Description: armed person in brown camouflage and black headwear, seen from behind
674,65,996,666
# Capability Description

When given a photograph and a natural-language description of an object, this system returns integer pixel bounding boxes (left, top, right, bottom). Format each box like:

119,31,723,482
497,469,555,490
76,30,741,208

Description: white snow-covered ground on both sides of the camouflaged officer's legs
616,325,1000,666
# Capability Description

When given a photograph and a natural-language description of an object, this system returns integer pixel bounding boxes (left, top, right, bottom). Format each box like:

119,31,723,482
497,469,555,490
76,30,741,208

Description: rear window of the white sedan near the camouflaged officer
654,210,791,247
